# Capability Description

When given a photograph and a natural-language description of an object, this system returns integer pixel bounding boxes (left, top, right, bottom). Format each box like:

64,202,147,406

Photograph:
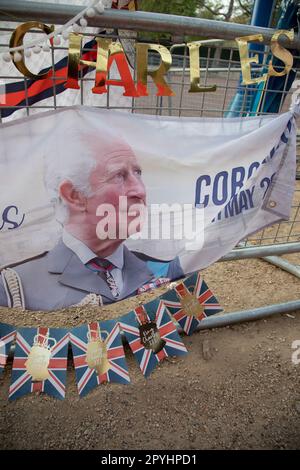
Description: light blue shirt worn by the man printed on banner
62,229,124,293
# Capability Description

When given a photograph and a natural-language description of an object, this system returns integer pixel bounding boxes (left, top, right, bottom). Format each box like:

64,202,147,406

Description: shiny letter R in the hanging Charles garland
136,44,175,96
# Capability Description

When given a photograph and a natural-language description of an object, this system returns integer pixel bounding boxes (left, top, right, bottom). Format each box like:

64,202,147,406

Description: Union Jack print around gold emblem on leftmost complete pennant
9,327,69,400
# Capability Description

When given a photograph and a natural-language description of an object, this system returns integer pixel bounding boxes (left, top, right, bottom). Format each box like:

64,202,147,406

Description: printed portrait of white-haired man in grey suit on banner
0,125,183,311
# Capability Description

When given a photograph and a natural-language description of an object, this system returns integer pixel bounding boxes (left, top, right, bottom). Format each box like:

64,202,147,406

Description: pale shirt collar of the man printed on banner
62,229,124,269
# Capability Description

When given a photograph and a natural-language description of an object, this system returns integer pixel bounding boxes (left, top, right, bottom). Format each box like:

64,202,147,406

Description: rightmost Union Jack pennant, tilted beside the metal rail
160,273,223,335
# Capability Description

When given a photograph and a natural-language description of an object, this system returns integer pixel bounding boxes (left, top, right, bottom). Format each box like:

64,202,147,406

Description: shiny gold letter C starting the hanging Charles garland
9,21,54,79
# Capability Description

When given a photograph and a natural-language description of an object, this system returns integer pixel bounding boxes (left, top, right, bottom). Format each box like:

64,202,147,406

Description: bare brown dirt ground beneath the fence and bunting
0,254,300,450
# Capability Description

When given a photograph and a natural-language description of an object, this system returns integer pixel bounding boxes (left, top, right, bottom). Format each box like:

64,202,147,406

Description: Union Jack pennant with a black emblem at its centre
120,299,187,377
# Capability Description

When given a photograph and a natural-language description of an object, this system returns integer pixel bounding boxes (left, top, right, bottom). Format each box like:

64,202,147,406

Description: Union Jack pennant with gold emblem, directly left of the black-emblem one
70,320,130,396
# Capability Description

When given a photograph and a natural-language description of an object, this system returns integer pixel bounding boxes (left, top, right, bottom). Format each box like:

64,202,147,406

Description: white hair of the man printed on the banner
44,126,97,224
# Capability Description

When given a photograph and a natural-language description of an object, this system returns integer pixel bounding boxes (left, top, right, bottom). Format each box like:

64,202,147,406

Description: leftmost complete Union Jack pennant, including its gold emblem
9,327,69,400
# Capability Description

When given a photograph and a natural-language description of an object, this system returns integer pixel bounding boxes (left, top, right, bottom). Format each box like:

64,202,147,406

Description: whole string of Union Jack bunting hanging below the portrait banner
0,273,222,400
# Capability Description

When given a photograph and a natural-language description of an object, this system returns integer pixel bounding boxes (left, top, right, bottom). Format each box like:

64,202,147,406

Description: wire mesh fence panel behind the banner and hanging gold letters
0,14,300,250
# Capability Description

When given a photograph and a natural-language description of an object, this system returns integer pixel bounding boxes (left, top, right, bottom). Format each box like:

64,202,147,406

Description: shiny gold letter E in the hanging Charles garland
235,34,268,85
